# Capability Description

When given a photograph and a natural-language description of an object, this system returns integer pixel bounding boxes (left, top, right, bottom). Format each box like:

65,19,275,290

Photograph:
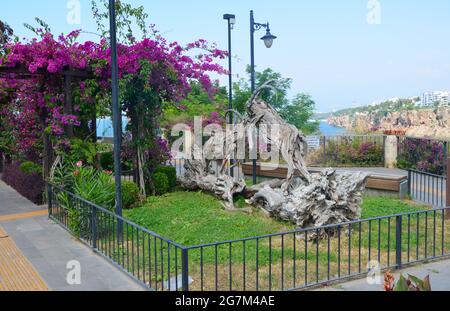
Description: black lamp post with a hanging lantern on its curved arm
250,11,277,185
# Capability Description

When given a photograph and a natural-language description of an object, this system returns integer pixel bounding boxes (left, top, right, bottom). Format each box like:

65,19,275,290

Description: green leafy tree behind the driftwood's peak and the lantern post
233,67,319,134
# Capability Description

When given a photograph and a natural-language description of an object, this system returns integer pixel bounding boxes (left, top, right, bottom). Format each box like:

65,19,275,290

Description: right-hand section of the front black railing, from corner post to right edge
181,209,450,291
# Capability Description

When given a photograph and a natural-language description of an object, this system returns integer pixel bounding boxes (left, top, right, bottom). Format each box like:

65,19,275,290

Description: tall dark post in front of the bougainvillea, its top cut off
109,0,122,216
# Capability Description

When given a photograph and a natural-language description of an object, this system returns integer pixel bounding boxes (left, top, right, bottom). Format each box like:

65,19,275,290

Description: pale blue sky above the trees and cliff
0,0,450,112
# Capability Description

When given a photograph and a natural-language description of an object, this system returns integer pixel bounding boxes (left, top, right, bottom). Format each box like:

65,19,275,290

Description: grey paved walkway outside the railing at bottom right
317,260,450,291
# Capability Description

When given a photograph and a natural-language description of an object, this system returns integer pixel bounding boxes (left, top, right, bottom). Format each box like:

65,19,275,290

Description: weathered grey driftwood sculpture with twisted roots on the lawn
180,85,367,228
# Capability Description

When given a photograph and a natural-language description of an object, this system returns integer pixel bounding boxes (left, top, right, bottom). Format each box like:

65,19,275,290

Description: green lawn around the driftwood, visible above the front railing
125,191,426,246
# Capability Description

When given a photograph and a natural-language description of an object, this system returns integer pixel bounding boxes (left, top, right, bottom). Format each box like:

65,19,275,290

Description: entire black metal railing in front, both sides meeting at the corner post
48,184,450,291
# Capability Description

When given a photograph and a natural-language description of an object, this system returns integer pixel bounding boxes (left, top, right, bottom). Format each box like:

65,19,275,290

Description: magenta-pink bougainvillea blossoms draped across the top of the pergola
0,26,228,157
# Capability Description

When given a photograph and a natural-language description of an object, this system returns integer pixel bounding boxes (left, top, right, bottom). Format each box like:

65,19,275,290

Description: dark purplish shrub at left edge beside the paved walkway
2,164,45,204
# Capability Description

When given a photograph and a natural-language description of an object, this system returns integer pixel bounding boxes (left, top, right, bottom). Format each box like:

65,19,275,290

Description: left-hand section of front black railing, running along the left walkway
48,184,187,291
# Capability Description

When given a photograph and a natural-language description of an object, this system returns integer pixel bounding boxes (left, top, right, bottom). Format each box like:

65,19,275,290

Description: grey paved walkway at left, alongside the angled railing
0,181,143,291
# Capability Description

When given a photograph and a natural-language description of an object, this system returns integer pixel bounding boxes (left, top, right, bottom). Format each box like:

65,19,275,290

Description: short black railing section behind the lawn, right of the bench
408,170,448,207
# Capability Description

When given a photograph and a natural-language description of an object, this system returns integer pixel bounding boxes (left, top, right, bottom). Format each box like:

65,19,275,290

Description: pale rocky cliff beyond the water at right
328,107,450,139
